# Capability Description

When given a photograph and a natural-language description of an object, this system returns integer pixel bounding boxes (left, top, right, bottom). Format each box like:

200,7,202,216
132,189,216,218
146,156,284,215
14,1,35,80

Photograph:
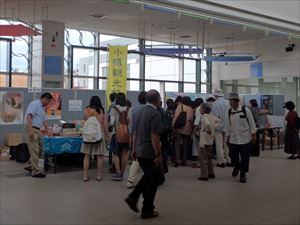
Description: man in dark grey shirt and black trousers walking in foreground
125,90,164,219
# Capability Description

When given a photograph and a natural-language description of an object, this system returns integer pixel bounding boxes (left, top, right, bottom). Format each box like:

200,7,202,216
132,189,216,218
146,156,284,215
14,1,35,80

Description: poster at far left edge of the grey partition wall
0,91,24,125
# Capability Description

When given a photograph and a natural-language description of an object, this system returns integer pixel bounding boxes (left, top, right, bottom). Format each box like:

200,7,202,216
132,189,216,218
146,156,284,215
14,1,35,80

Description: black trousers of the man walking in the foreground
129,158,160,213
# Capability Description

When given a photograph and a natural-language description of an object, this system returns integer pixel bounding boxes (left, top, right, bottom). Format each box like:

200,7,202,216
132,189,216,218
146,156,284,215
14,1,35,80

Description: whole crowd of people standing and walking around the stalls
25,89,300,218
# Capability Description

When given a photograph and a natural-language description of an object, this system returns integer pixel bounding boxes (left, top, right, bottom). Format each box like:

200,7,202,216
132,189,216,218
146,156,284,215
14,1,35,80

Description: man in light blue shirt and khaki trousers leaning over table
24,93,53,178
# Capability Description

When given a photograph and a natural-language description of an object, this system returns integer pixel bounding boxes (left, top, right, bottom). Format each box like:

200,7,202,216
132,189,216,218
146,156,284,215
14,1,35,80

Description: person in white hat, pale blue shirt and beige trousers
211,89,232,168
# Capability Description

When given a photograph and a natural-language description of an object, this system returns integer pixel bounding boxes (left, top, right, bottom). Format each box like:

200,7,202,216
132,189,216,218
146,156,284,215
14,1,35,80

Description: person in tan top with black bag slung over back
172,96,194,167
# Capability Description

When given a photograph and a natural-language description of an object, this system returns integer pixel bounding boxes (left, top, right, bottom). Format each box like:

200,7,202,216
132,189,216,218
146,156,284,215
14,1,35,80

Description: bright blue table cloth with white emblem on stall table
43,136,82,155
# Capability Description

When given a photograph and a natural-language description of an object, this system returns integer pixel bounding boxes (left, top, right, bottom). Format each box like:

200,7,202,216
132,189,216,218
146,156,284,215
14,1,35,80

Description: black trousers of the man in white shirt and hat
229,143,251,176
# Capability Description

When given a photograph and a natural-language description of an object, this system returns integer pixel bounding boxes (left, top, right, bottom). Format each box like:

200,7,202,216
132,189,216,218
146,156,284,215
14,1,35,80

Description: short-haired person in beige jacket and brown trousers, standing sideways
198,103,221,181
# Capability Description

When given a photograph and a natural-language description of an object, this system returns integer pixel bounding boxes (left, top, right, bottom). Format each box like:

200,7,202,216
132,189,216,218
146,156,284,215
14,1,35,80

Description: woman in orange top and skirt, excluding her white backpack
81,96,109,182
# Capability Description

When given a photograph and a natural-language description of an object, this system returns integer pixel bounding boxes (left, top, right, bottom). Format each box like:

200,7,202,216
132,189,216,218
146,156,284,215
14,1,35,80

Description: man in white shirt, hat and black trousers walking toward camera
225,93,256,183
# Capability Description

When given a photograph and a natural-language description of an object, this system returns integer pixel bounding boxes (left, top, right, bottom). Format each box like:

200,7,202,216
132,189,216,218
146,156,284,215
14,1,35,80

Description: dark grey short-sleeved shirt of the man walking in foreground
136,104,162,159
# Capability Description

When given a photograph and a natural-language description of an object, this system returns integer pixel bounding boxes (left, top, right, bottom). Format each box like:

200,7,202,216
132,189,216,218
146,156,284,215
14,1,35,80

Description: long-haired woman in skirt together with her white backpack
81,96,109,182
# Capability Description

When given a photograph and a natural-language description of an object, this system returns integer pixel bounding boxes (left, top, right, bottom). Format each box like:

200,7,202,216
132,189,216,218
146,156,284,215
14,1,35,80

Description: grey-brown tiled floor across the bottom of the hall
0,150,300,225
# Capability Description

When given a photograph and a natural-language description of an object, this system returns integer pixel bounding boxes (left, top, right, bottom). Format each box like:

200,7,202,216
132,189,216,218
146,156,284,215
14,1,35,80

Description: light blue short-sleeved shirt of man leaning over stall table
24,99,47,128
